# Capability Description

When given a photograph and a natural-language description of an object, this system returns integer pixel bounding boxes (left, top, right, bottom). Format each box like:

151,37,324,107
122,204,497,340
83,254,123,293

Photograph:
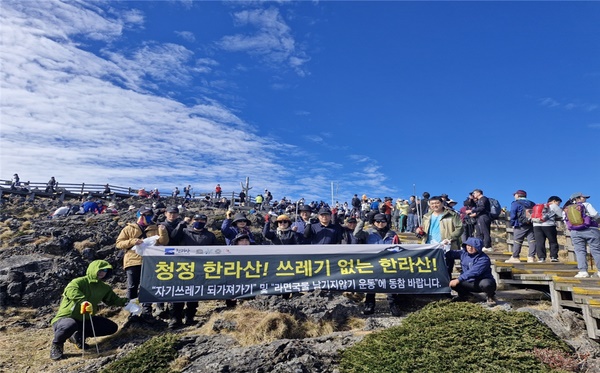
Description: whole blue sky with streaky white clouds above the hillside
0,0,600,205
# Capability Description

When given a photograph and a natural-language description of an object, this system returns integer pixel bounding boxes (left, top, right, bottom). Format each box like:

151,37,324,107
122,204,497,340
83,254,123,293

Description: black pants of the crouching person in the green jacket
52,315,119,343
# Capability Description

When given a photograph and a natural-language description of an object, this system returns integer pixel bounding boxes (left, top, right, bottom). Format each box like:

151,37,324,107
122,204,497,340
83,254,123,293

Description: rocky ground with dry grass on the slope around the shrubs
0,198,600,373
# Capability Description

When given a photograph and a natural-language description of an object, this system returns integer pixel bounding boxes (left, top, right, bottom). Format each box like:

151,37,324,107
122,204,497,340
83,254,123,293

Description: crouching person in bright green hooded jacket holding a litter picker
50,260,128,360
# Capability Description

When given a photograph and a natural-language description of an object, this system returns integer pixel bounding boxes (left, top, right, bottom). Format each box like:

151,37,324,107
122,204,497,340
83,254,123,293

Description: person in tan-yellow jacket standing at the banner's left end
116,206,169,323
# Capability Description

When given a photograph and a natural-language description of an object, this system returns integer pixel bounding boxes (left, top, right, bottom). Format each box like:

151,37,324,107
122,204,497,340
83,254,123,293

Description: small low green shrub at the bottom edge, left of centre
101,334,177,373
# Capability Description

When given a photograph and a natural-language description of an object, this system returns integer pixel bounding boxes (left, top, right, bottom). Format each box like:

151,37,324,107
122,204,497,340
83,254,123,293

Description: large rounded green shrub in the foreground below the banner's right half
340,301,572,373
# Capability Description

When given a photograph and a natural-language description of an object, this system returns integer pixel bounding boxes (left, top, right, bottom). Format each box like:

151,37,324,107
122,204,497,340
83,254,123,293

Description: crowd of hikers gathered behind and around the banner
39,182,600,359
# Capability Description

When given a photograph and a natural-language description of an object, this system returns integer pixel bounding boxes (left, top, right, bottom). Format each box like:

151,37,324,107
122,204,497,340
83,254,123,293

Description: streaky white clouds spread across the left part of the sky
0,1,384,200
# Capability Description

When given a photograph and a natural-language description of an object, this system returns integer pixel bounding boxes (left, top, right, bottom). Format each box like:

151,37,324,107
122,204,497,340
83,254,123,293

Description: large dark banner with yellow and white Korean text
139,245,450,302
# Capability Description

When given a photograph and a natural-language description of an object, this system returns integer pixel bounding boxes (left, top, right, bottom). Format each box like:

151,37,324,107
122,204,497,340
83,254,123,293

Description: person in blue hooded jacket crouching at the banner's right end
446,237,496,306
